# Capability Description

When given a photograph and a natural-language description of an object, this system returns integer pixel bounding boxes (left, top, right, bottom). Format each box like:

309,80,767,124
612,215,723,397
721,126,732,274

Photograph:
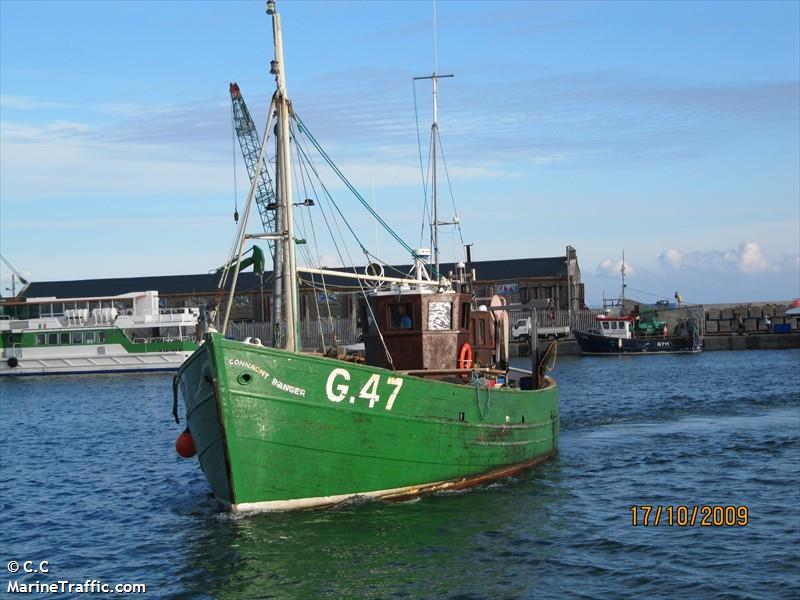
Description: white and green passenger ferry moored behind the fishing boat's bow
0,291,198,377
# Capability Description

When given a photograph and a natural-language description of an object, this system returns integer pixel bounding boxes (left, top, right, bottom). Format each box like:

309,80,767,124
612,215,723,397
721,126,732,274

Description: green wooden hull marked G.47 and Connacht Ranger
178,334,559,510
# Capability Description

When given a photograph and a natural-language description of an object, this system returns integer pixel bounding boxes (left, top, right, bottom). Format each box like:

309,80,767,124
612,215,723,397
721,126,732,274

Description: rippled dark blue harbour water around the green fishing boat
0,350,800,599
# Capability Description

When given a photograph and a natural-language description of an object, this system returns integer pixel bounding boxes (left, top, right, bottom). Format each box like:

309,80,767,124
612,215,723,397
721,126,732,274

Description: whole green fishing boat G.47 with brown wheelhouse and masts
173,1,559,511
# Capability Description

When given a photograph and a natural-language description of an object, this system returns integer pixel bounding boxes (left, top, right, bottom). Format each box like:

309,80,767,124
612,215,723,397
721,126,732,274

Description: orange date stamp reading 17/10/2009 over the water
630,504,750,527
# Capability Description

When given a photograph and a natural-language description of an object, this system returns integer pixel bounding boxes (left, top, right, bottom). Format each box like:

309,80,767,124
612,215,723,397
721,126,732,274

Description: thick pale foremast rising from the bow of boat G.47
267,0,300,352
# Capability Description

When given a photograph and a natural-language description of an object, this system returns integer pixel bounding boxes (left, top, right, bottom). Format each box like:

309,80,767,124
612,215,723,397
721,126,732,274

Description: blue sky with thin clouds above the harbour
0,0,800,305
